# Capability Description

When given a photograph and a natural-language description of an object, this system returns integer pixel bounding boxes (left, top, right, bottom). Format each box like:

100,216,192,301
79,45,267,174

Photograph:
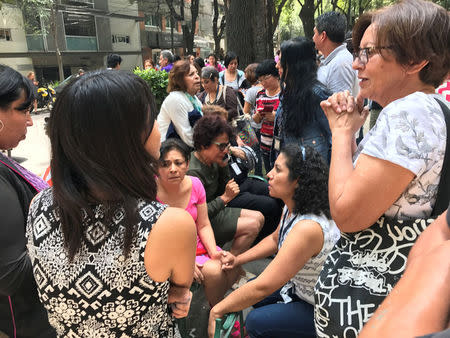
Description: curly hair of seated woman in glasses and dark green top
193,115,233,150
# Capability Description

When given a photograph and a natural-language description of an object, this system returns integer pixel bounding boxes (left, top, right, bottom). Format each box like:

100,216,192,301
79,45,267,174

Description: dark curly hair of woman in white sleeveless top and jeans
281,144,331,219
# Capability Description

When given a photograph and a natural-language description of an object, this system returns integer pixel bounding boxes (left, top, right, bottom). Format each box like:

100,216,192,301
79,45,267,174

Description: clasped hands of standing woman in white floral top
320,90,369,134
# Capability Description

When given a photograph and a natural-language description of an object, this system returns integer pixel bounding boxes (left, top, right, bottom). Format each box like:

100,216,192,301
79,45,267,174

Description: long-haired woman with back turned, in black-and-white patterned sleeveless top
27,71,195,337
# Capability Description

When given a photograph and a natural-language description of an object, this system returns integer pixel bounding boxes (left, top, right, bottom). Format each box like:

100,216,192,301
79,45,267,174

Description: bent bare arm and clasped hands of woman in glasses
321,93,414,232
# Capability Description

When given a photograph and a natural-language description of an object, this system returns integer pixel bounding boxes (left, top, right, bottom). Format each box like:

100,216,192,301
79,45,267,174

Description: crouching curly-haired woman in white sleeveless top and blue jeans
208,144,339,338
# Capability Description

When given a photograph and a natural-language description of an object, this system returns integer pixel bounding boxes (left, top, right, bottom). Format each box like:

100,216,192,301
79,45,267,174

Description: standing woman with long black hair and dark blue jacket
272,37,331,163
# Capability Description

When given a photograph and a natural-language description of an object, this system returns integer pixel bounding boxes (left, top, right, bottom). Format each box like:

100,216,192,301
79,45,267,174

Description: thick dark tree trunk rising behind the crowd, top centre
226,0,256,69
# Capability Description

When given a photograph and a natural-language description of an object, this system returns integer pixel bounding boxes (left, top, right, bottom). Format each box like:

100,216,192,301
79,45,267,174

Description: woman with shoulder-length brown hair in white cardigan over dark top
158,60,202,147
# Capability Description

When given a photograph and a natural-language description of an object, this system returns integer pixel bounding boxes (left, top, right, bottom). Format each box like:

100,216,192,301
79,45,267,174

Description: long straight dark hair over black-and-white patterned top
49,70,157,260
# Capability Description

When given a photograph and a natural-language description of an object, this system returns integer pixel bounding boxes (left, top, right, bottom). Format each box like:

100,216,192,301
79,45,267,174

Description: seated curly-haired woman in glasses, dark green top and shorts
188,116,264,254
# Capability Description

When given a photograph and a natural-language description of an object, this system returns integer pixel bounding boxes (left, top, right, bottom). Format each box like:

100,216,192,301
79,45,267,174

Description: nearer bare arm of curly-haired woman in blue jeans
209,220,323,332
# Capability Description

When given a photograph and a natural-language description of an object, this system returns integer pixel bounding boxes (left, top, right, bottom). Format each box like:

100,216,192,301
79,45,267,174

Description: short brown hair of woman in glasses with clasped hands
372,0,450,88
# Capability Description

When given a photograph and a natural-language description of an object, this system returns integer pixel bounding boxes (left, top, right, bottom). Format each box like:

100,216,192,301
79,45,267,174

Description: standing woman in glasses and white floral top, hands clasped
315,0,450,337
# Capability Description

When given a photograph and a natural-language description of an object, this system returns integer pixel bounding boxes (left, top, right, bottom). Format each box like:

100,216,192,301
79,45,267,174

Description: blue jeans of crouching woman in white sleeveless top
245,290,316,338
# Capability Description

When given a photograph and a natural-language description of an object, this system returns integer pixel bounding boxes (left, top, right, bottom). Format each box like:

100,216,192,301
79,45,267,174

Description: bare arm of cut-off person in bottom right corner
359,240,450,338
